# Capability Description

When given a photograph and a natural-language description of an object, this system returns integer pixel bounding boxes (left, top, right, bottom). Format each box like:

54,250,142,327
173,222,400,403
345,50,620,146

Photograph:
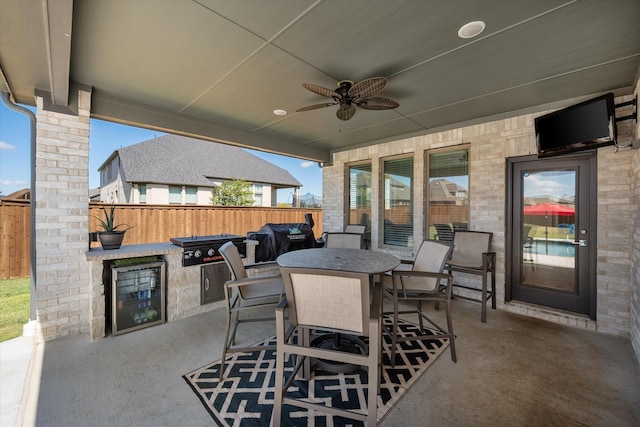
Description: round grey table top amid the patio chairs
276,248,400,274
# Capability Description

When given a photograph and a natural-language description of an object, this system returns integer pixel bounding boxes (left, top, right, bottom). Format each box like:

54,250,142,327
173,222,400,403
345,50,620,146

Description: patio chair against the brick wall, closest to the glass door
445,231,496,323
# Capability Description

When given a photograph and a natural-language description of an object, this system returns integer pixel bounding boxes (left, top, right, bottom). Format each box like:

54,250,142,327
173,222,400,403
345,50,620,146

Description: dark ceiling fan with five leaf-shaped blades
296,77,400,121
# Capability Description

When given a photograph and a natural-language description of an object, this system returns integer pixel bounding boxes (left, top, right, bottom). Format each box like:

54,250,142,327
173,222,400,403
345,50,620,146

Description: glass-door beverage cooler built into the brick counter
111,259,165,335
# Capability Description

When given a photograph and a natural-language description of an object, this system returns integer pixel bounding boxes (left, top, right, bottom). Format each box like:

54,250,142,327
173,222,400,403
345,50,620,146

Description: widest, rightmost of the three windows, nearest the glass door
426,147,469,241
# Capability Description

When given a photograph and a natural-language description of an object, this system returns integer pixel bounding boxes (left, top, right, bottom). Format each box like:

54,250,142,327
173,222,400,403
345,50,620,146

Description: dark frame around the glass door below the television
505,151,598,320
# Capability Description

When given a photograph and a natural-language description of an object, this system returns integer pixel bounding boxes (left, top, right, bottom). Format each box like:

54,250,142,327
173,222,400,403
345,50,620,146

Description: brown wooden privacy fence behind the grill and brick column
0,199,322,279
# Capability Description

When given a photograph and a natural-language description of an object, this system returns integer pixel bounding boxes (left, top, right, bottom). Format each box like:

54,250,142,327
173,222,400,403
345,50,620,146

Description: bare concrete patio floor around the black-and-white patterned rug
2,300,640,427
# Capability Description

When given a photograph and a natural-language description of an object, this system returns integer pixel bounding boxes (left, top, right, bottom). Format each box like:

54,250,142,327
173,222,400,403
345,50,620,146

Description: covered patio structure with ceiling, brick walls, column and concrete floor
0,0,640,426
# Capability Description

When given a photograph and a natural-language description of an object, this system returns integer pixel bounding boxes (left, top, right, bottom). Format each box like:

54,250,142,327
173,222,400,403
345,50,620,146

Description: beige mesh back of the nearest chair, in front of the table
280,267,370,336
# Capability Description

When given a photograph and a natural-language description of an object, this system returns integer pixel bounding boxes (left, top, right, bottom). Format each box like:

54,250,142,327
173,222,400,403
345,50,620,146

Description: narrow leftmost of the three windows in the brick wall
347,163,371,233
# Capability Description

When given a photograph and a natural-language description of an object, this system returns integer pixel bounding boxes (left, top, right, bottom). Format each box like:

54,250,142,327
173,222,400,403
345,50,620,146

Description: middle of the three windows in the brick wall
382,157,413,247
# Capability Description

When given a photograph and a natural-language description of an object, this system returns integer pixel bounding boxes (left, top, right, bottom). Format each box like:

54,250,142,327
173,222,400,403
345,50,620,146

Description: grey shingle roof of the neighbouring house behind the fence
116,135,302,187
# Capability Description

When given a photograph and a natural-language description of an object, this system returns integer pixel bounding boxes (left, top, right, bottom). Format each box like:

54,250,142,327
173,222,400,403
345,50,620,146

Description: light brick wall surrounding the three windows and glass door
323,92,640,366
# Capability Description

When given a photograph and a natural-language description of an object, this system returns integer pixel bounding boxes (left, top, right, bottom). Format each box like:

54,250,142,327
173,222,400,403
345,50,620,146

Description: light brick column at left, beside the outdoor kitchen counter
32,90,91,340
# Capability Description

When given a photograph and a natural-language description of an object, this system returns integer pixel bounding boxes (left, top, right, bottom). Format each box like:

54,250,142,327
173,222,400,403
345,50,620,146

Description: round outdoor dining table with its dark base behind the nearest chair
276,248,400,373
